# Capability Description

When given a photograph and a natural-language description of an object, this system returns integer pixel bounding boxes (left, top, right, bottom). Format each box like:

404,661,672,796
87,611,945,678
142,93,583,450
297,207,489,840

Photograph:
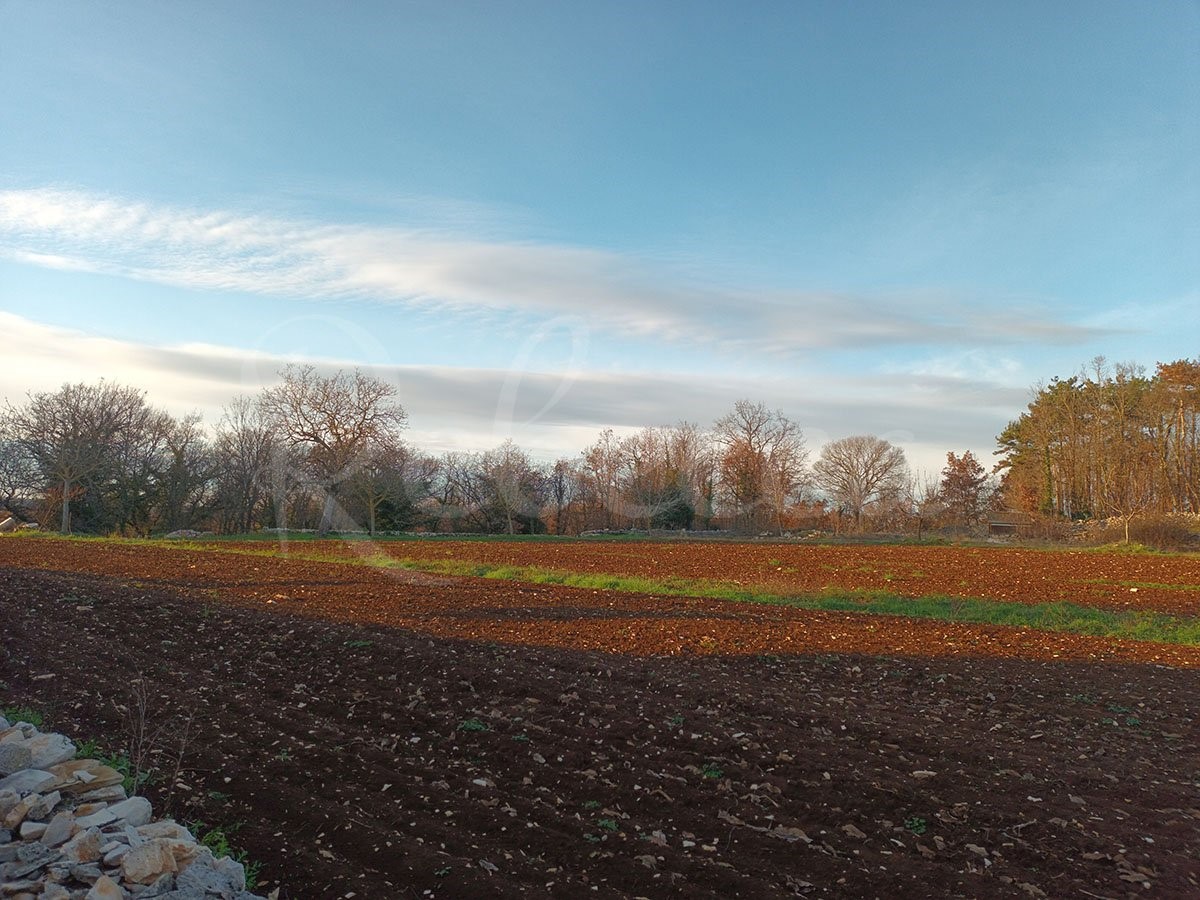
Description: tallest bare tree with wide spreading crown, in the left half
259,366,408,534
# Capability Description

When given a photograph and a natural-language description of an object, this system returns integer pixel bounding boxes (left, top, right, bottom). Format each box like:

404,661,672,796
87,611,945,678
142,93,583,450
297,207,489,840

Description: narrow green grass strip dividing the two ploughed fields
11,535,1200,646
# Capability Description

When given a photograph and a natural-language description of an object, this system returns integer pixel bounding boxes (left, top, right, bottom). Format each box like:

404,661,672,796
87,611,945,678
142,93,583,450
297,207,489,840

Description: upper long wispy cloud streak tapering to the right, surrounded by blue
0,190,1103,355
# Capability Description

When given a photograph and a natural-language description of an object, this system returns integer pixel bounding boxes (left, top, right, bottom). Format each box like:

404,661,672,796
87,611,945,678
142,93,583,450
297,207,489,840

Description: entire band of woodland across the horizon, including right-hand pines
0,359,1200,538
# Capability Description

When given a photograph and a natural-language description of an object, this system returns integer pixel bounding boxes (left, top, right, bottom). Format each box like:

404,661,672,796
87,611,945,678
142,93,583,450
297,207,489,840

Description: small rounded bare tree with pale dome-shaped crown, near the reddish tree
812,434,908,530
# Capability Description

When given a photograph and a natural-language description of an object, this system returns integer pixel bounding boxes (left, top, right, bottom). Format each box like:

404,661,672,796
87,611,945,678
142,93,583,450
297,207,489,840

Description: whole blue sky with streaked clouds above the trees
0,0,1200,480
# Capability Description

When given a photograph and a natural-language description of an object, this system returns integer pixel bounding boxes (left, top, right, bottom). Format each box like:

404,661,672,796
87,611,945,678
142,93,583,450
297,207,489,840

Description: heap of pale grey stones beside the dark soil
0,716,262,900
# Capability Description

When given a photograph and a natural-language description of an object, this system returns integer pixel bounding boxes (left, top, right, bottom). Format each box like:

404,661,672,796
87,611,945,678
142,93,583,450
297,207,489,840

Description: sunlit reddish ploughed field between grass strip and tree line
255,540,1200,616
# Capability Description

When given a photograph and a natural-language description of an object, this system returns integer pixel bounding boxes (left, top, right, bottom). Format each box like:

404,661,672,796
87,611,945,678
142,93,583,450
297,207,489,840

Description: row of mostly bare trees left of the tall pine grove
0,366,1008,535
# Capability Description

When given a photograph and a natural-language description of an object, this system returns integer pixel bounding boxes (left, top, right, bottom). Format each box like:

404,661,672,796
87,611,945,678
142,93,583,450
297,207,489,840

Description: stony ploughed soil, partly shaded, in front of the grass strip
0,539,1200,898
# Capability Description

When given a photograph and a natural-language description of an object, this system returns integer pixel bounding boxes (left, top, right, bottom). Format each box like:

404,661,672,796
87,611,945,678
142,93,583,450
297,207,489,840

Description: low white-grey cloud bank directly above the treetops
0,312,1025,470
